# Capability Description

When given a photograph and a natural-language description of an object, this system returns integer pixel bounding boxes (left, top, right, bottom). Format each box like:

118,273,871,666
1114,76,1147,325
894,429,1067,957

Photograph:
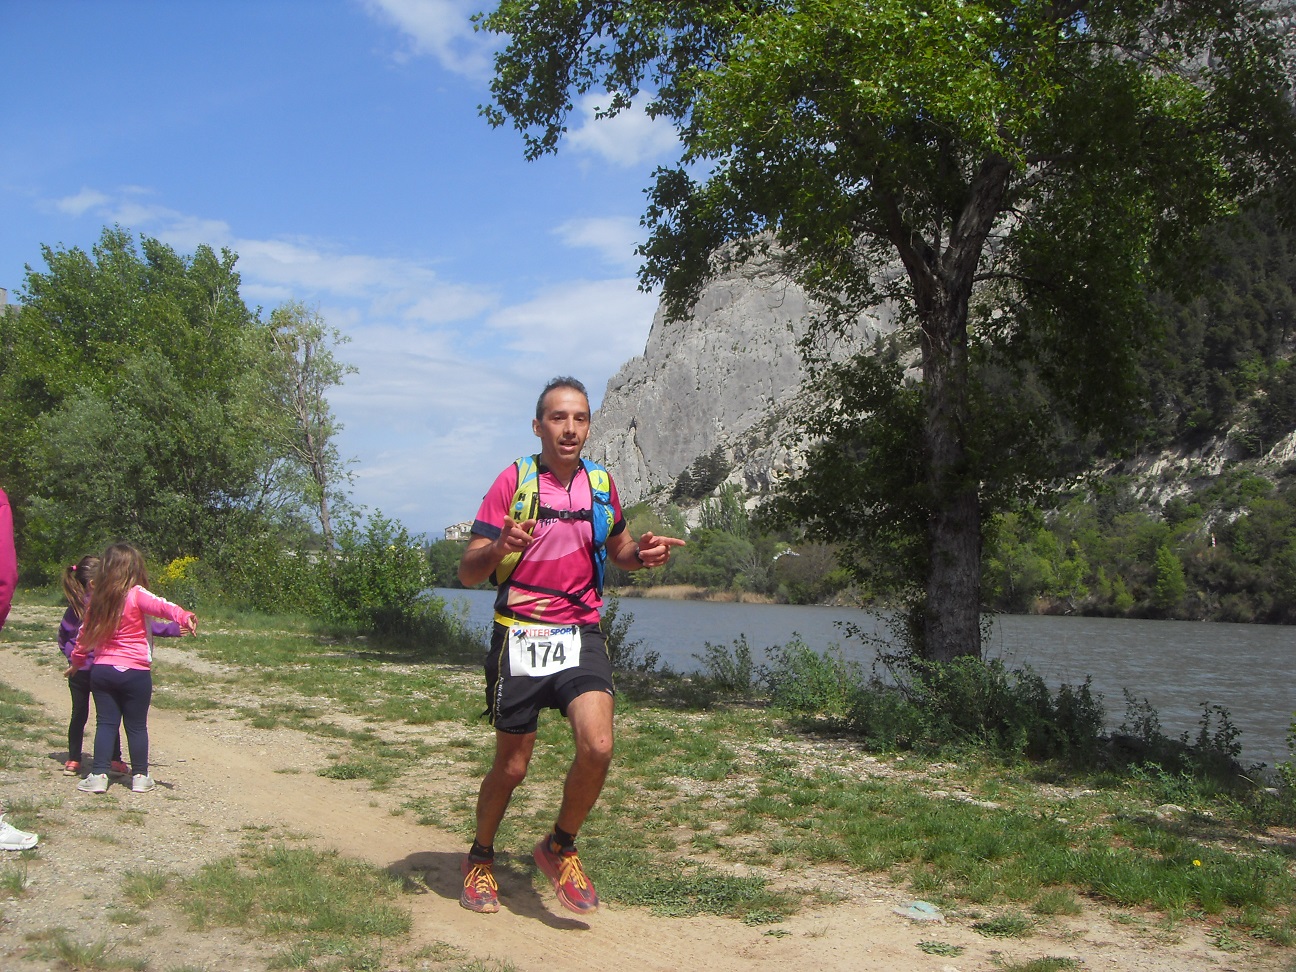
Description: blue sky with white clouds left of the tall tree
0,0,675,537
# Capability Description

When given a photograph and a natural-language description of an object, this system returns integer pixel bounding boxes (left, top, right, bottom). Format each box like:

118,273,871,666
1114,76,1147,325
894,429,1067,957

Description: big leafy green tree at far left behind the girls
0,228,321,581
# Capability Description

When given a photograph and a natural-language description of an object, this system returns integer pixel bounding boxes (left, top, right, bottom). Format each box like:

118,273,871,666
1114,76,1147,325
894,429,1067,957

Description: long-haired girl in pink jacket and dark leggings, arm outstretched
64,543,197,793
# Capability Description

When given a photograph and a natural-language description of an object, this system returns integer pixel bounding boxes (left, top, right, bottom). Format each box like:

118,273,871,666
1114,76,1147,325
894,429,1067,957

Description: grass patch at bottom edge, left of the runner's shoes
179,844,411,972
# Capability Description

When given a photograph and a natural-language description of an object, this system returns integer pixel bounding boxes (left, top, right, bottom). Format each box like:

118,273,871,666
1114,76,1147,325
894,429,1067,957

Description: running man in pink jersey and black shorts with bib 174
459,377,684,914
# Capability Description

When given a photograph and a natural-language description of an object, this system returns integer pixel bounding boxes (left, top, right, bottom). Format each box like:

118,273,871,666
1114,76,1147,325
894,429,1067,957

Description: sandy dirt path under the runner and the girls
0,608,1296,972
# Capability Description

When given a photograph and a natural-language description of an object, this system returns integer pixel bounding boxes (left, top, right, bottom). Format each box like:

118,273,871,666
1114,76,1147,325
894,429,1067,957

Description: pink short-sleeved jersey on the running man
473,465,625,625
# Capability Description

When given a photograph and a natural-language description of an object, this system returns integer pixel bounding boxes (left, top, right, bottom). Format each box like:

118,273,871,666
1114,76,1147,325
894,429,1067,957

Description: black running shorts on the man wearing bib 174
486,622,616,734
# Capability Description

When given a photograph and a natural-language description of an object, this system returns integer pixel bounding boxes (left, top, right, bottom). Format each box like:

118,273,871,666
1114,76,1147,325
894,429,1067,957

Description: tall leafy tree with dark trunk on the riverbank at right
480,0,1296,660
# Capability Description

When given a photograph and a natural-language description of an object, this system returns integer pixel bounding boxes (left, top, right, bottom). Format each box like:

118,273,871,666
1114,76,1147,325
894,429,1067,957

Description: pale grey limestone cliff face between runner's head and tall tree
586,259,894,505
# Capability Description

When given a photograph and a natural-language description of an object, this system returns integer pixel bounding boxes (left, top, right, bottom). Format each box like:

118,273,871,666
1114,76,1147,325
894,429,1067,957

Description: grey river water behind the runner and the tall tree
437,588,1296,767
